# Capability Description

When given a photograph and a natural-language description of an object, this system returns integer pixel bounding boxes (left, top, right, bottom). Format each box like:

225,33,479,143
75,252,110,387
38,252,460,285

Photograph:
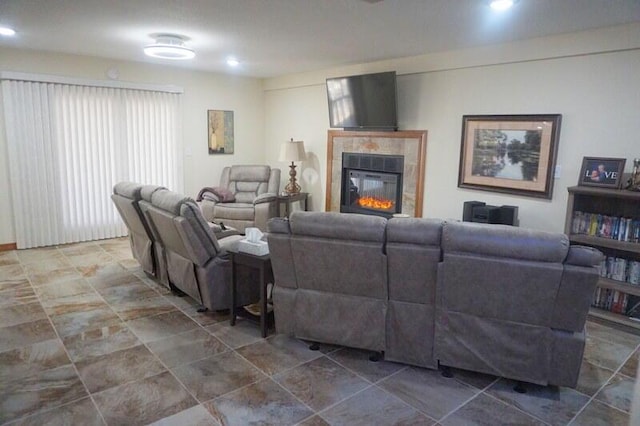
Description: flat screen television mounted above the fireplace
327,71,398,130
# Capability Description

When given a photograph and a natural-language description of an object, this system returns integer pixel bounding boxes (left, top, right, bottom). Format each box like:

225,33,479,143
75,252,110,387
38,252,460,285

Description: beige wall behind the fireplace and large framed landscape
265,24,640,231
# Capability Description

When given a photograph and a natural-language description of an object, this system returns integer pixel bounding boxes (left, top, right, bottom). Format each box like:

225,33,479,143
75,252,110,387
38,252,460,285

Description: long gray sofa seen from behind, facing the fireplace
268,212,602,387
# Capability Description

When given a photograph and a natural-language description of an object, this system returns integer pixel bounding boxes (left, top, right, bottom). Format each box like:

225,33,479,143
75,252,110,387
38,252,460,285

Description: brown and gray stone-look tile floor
0,239,640,426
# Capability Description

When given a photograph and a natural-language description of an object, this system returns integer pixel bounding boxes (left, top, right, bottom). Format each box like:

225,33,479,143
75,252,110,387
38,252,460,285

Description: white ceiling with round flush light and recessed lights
0,0,640,77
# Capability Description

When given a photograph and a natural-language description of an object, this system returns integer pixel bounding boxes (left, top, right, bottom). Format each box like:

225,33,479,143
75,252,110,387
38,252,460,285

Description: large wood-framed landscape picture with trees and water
458,114,562,199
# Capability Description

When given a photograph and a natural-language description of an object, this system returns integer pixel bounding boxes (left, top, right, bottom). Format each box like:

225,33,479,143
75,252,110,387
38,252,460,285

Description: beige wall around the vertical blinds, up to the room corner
0,48,265,244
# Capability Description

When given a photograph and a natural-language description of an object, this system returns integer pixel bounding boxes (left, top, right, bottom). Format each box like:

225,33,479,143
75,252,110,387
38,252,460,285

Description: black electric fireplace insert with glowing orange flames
340,152,404,218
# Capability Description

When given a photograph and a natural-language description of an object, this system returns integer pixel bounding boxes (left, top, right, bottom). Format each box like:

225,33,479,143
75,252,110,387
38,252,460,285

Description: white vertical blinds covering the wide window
2,80,182,248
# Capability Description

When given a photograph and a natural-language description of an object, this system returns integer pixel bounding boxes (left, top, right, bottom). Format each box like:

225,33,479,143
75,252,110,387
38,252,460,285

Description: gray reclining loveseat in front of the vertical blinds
112,182,260,310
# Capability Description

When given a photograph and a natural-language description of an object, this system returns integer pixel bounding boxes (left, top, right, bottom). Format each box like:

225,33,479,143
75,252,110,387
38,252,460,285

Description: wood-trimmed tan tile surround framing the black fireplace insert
325,130,427,217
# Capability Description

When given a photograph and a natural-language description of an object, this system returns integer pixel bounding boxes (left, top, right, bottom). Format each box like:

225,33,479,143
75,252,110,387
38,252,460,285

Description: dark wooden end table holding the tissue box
229,251,273,337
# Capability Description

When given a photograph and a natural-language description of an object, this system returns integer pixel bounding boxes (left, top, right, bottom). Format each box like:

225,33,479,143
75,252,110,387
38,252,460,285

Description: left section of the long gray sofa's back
267,212,388,351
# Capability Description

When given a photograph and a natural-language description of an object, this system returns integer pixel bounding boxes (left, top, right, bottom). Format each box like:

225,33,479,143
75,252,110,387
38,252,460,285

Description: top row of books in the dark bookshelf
571,211,640,243
